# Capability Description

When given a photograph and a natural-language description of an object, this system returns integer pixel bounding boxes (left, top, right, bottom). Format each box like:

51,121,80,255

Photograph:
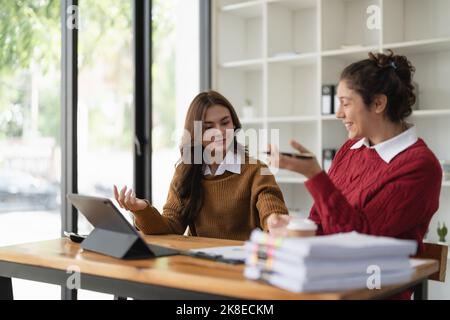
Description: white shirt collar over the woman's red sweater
350,125,418,163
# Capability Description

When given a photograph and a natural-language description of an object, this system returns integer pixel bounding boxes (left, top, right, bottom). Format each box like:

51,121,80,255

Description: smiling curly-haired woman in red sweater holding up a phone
270,51,442,298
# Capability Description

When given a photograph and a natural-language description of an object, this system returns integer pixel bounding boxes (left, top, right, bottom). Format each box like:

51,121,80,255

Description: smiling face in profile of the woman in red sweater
336,80,379,139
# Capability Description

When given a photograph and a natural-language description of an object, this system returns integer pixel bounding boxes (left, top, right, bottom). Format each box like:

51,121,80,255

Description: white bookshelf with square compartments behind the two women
213,0,450,268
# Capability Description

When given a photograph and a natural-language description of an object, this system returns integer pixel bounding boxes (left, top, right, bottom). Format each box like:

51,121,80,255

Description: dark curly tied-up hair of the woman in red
340,50,416,123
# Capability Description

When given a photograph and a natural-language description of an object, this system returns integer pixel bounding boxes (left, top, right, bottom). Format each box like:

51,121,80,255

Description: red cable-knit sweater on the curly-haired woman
305,139,442,298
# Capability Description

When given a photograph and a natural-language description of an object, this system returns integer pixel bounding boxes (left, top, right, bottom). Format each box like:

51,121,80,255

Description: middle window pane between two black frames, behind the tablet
78,0,134,300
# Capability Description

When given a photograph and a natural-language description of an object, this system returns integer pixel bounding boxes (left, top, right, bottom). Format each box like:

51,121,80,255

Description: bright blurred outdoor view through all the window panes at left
0,0,199,299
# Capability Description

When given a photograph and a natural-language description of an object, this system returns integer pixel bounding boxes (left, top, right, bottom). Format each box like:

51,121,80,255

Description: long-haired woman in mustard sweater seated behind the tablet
114,91,288,240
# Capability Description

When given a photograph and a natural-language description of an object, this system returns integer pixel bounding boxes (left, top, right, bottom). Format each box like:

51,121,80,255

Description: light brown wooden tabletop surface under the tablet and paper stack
0,235,438,300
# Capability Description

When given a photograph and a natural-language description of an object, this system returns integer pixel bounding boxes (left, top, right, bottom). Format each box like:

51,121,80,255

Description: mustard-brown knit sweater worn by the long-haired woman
134,158,288,240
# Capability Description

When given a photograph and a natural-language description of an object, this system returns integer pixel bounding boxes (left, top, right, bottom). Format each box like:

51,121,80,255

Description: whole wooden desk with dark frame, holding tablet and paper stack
0,235,438,300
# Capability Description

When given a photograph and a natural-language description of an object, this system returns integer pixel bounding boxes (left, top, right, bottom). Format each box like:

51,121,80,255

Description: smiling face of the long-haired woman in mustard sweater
202,105,235,153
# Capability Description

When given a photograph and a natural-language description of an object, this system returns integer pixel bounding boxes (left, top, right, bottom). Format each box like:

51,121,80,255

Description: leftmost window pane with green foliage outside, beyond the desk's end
0,0,61,299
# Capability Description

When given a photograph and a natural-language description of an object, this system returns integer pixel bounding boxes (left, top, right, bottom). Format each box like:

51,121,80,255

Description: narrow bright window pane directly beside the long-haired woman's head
152,0,200,212
